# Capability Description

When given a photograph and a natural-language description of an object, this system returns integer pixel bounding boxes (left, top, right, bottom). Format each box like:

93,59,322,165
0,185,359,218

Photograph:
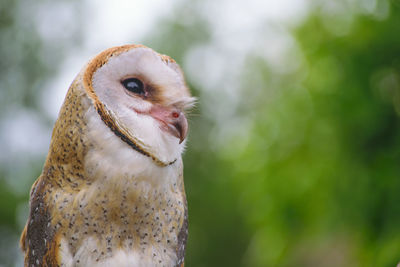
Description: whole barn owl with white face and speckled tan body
21,45,195,266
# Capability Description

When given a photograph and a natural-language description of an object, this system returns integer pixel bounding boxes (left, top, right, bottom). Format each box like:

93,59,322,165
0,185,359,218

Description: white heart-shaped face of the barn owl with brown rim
86,46,194,168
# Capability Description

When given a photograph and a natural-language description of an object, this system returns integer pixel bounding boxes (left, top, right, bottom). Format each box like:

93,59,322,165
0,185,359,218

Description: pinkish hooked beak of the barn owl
150,106,188,144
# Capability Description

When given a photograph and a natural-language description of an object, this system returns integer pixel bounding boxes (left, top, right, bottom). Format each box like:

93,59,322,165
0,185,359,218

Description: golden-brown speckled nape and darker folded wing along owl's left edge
21,77,91,266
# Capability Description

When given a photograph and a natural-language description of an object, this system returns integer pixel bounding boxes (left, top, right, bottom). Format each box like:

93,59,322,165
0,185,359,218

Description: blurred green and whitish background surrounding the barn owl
0,0,400,267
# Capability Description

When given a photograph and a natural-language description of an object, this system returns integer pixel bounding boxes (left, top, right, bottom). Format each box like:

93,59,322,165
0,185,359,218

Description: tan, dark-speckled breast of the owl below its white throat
54,171,186,266
